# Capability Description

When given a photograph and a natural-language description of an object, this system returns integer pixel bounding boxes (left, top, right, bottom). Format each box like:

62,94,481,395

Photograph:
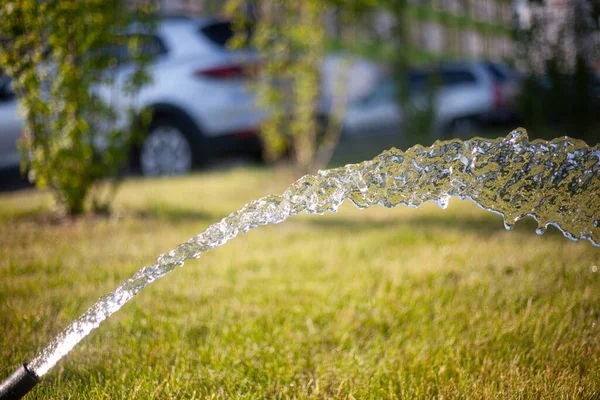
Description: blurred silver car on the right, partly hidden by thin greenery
346,61,521,137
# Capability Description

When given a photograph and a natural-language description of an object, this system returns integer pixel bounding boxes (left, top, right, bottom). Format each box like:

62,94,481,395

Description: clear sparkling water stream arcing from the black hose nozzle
28,129,600,377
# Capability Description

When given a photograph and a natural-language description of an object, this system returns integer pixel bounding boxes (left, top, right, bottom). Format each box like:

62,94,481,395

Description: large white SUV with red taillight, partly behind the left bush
0,17,265,175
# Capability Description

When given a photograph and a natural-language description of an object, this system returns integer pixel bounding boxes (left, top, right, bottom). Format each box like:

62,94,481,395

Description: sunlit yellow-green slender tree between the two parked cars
226,0,354,174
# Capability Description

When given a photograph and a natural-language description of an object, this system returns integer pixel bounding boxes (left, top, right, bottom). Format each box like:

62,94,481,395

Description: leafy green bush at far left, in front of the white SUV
0,0,154,215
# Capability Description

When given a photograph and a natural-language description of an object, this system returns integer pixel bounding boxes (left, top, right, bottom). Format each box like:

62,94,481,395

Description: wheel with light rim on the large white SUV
140,120,193,176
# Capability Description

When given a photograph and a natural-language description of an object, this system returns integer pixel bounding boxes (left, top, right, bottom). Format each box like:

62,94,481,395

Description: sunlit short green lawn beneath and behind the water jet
0,169,600,399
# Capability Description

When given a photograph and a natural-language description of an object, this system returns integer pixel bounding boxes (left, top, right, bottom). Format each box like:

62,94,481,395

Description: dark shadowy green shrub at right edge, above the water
515,0,600,144
